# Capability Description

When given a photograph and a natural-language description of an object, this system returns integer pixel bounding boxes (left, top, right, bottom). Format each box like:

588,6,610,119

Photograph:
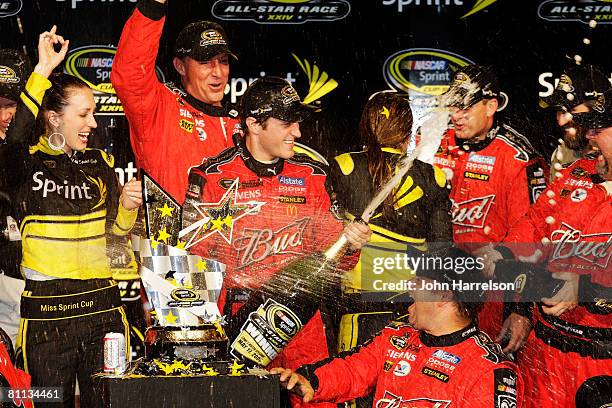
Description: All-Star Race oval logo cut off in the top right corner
538,0,612,24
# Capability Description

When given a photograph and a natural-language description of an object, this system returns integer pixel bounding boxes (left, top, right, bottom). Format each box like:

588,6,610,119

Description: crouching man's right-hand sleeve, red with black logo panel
461,364,523,408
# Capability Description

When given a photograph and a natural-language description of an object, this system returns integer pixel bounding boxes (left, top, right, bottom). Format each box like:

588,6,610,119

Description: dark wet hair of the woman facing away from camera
359,92,412,217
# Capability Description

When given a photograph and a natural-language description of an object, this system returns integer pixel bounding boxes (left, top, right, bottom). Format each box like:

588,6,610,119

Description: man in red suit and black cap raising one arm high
111,0,238,202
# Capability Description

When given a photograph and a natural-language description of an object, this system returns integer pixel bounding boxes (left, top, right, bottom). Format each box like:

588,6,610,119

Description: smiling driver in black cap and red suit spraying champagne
183,77,371,408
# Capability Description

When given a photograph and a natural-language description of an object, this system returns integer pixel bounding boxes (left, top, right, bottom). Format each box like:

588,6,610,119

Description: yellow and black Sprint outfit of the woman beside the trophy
9,73,137,407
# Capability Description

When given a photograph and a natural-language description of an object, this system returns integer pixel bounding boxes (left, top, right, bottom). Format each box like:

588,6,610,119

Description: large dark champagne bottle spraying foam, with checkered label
227,235,349,367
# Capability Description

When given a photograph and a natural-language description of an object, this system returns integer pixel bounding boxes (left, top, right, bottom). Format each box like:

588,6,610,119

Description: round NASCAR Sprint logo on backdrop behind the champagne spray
383,48,474,122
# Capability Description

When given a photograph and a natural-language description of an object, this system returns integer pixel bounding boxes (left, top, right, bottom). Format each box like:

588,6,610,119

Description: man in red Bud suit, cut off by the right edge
500,91,612,408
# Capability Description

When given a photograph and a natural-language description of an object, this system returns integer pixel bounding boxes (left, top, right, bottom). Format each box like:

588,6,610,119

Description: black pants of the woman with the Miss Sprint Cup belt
20,280,129,408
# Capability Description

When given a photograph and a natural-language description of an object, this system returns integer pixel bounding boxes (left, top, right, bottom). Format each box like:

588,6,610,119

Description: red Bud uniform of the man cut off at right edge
522,172,612,408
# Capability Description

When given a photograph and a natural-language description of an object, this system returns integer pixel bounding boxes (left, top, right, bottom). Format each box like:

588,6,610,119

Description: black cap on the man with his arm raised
174,21,238,61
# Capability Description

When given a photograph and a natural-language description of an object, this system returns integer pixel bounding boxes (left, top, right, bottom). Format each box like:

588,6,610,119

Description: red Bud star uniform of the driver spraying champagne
183,145,343,407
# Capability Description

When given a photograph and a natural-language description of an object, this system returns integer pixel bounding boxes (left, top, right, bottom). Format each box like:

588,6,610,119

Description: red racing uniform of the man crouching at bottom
298,325,523,408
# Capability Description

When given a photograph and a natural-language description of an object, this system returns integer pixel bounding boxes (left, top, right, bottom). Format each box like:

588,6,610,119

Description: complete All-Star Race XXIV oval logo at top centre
211,0,351,24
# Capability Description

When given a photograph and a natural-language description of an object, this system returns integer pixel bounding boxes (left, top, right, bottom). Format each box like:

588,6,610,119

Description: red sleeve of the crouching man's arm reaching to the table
311,330,388,403
